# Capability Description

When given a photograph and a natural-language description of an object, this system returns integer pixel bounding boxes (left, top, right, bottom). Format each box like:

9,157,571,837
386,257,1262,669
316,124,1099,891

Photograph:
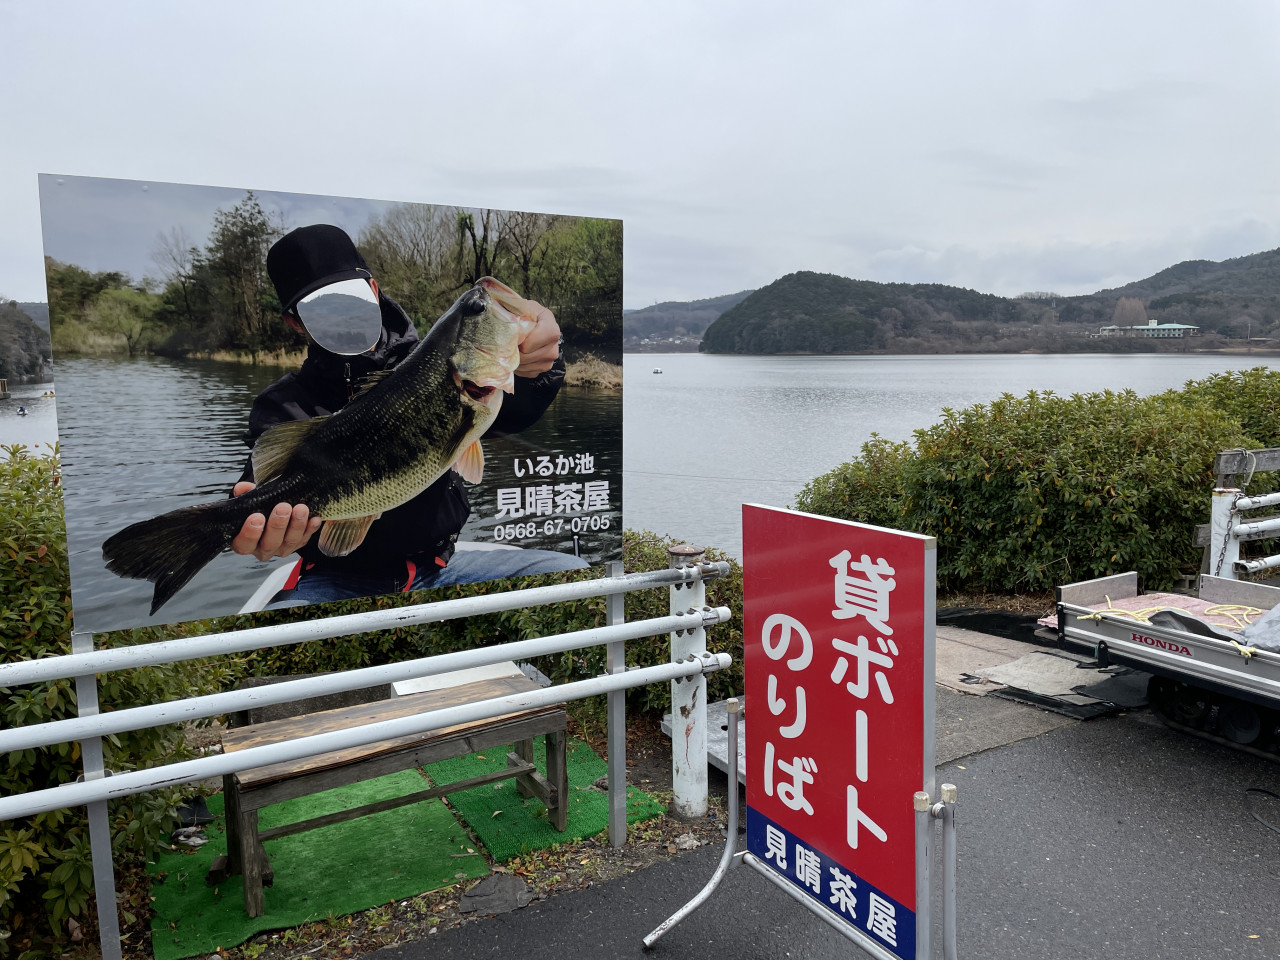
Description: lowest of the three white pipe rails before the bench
0,653,732,822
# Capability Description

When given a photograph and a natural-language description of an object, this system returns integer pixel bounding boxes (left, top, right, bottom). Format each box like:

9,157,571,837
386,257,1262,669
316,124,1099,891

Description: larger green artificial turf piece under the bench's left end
151,769,492,960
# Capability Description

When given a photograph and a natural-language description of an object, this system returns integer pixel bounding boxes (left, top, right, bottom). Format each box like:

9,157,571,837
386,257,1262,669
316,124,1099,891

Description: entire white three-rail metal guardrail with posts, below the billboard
0,548,732,960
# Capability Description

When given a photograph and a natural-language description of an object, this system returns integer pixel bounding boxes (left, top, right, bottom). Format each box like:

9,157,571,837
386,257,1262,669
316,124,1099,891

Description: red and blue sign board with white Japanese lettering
742,504,937,957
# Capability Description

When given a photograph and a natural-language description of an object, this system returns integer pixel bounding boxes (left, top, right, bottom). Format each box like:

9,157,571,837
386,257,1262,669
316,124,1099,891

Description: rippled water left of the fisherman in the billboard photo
56,358,294,632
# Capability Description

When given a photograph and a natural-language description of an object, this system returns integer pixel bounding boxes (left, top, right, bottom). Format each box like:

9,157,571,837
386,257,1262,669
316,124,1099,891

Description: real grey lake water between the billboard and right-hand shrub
623,353,1277,557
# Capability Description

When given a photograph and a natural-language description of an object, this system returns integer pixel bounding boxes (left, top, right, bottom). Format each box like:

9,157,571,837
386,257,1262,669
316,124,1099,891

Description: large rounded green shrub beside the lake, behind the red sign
796,369,1280,591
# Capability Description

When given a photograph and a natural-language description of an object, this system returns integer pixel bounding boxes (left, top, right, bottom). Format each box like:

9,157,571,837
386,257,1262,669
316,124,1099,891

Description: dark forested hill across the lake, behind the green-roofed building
699,250,1280,353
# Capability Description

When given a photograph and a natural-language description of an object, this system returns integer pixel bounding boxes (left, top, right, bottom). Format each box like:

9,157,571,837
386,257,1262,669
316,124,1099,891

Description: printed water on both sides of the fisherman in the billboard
56,358,622,632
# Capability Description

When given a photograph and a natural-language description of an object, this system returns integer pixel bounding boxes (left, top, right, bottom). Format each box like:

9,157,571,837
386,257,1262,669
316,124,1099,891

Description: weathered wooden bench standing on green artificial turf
209,673,568,916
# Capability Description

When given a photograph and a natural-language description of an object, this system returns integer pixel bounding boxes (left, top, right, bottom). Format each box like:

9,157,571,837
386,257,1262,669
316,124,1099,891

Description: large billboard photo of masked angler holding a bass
40,175,622,632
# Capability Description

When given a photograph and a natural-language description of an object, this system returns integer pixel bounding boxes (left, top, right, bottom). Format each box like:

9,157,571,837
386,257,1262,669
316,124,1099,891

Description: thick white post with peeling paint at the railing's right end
667,544,707,819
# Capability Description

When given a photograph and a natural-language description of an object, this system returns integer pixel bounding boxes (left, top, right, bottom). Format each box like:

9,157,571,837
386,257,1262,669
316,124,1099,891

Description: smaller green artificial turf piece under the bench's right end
424,737,666,865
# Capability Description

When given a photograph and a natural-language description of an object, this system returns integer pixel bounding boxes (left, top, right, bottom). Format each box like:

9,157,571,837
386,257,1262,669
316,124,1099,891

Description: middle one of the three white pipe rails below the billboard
0,607,732,754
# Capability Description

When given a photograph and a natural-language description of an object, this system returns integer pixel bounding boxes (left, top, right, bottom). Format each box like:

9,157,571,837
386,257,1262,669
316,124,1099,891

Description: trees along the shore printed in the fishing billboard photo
36,192,622,365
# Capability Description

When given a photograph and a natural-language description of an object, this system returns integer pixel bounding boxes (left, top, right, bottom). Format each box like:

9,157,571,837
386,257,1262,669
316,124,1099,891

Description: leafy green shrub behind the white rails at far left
0,445,228,955
